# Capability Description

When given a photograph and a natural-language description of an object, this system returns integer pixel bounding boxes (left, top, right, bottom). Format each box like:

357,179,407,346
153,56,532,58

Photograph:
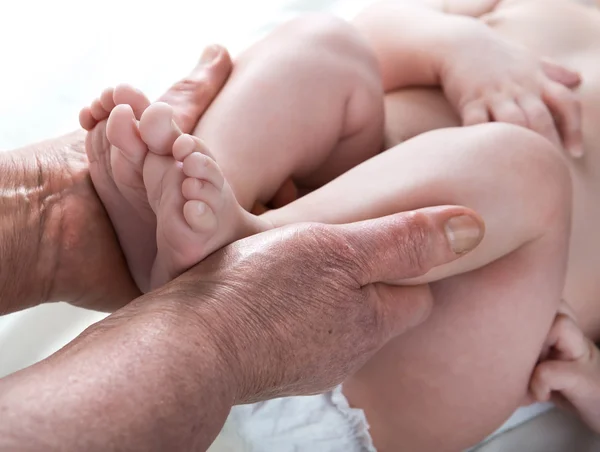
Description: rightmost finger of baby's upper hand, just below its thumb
542,83,583,158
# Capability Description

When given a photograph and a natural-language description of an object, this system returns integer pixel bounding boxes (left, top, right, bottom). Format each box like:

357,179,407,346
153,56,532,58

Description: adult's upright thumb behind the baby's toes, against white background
158,45,232,133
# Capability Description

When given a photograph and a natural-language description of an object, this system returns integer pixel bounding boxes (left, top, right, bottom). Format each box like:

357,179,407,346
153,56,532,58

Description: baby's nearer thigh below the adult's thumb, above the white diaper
344,248,560,452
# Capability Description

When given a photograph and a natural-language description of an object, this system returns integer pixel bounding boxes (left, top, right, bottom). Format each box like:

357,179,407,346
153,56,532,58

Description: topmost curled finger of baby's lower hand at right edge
547,314,589,361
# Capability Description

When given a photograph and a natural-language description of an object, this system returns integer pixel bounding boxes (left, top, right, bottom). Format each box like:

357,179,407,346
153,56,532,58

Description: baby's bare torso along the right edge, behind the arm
483,0,600,337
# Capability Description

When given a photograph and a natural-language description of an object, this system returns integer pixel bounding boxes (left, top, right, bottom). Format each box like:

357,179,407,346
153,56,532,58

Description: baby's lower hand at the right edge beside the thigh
529,302,600,433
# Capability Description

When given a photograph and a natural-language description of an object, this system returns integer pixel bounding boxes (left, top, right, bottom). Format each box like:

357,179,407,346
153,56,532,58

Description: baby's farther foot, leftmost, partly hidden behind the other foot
79,85,156,291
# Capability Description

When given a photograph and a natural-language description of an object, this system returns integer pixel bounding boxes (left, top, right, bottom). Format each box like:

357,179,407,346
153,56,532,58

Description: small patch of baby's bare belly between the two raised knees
384,88,461,149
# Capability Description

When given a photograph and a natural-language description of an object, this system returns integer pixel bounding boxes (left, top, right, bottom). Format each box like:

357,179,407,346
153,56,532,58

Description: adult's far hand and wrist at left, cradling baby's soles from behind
0,46,232,315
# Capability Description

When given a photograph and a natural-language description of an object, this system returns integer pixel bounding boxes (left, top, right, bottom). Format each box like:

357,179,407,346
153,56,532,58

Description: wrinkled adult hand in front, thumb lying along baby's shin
157,207,483,403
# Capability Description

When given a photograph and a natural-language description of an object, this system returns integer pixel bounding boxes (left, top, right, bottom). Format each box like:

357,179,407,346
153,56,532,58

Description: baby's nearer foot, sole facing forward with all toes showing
140,103,271,287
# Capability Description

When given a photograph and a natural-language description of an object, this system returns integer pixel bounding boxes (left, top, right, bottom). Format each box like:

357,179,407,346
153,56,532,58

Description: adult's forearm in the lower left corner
0,296,235,452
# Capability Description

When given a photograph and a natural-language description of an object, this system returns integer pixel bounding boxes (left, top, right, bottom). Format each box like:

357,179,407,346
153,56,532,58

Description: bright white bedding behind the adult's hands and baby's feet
0,0,580,448
